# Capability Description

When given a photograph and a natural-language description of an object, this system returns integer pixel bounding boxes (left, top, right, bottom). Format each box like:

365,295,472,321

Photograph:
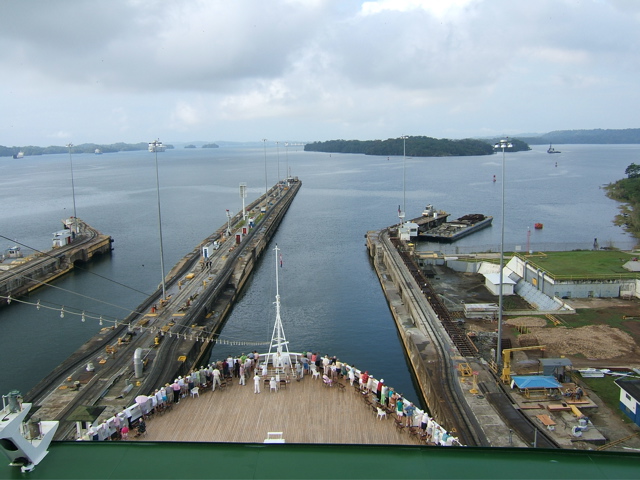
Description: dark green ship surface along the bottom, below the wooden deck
0,441,640,480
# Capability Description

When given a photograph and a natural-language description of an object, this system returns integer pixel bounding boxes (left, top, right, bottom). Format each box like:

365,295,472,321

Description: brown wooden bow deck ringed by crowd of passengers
136,376,424,445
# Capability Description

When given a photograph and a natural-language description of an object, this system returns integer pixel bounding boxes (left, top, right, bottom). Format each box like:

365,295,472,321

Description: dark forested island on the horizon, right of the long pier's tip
304,136,531,157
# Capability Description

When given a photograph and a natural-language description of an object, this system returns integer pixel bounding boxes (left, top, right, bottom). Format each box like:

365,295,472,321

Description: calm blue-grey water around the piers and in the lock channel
0,145,640,399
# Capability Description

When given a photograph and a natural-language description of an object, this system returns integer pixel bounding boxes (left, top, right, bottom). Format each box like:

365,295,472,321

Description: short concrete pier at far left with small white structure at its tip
0,218,113,305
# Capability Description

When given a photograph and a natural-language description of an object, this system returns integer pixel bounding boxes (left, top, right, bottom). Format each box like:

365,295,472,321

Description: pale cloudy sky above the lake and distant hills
0,0,640,146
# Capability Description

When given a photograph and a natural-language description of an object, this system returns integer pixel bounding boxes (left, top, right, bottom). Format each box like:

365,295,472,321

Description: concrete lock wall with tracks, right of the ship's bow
366,229,558,448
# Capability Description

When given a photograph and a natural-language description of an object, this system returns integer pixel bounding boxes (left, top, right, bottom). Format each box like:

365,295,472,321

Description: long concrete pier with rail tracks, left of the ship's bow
25,178,302,440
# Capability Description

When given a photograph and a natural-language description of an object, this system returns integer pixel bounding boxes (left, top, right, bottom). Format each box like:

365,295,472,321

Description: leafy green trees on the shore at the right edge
605,163,640,239
